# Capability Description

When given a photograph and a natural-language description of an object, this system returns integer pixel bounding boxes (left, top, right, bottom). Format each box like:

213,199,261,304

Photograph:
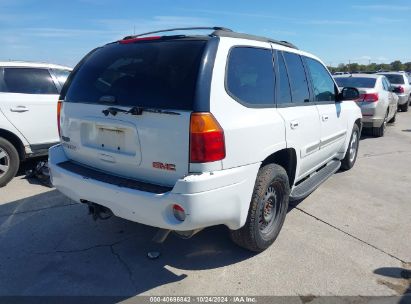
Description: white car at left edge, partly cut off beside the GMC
0,61,71,187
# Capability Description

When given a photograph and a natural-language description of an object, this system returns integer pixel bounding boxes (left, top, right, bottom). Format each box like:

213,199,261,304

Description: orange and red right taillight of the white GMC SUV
190,113,225,163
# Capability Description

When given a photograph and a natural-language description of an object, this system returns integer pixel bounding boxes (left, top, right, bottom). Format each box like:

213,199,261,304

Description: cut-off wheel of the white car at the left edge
0,137,20,187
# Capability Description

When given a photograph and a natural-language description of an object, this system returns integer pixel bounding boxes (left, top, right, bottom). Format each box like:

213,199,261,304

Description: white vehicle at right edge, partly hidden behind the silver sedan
378,72,411,112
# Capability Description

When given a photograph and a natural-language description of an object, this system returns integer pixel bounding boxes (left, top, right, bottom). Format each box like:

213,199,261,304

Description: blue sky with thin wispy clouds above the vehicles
0,0,411,66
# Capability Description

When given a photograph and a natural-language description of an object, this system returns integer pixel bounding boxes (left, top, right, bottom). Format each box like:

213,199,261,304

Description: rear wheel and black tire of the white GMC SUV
230,164,290,252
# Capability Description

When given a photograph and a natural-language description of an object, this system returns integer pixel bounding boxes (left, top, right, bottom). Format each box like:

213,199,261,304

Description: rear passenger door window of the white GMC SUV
284,52,310,103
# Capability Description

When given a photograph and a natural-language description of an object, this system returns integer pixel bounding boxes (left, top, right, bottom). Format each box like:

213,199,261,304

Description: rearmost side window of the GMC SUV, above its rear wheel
226,47,275,106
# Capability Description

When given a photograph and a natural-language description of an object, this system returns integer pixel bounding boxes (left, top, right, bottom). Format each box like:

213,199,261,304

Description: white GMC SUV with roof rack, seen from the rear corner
49,28,361,251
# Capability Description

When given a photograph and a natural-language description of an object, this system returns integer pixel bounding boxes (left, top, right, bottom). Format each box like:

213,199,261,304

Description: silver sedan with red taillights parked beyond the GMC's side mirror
334,74,398,136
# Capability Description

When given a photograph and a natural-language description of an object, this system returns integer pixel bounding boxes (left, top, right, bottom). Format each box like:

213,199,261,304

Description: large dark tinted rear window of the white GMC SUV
65,40,207,110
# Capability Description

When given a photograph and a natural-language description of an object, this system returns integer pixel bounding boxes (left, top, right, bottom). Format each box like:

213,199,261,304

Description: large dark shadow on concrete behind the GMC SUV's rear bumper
0,190,253,302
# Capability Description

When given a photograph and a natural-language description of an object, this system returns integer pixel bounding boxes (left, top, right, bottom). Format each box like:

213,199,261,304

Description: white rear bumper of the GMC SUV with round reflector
49,145,260,231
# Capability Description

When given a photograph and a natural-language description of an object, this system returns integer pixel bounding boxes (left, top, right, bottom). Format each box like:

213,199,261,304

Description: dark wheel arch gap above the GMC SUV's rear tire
261,148,297,187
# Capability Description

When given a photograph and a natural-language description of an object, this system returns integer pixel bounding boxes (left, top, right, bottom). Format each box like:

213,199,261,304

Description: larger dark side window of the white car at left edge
4,68,58,94
